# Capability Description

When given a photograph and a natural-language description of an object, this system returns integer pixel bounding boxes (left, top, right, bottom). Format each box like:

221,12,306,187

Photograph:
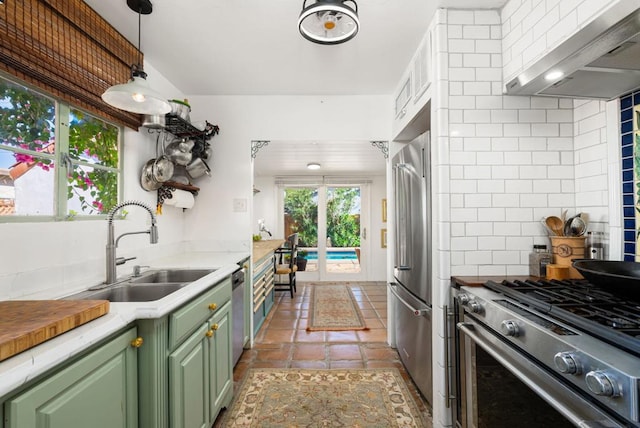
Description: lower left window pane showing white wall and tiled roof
0,148,55,216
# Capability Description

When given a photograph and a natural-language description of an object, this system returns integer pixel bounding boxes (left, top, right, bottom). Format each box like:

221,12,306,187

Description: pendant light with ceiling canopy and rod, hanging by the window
102,0,171,115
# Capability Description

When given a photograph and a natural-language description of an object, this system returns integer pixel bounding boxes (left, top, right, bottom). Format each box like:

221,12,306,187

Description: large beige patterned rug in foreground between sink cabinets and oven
223,369,427,428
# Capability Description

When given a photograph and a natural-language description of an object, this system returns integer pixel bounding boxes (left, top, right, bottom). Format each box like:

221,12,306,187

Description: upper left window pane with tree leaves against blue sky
0,79,55,153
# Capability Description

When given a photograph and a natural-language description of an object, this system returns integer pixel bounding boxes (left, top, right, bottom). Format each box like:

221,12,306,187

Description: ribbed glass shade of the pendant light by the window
102,76,171,115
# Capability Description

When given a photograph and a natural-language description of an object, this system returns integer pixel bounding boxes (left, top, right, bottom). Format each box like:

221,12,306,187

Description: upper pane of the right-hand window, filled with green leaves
69,110,118,168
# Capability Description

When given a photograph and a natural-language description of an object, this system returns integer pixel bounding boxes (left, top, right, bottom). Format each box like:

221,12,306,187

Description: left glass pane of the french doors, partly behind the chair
284,187,318,271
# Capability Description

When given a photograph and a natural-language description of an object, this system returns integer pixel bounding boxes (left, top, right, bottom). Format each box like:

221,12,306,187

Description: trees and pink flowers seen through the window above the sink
0,79,119,215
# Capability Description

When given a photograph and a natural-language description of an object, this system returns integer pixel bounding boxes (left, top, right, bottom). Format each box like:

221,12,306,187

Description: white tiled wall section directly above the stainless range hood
501,0,631,83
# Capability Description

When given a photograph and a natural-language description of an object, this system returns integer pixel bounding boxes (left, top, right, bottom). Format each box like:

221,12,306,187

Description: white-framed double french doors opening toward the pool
279,183,369,281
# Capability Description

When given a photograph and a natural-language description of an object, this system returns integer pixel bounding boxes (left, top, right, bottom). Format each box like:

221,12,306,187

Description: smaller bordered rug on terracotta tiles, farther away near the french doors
307,285,368,331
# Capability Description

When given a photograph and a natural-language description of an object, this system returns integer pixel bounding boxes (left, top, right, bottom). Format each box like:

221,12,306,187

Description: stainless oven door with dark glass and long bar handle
454,307,624,428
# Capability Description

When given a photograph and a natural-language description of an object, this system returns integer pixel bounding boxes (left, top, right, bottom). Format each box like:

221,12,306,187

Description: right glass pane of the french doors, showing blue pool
326,187,360,273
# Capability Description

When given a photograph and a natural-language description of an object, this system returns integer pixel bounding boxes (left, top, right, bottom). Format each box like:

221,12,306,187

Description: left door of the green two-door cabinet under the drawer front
169,323,210,428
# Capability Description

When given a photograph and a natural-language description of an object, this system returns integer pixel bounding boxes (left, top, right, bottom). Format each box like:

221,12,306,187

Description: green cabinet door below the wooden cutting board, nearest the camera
5,328,138,428
